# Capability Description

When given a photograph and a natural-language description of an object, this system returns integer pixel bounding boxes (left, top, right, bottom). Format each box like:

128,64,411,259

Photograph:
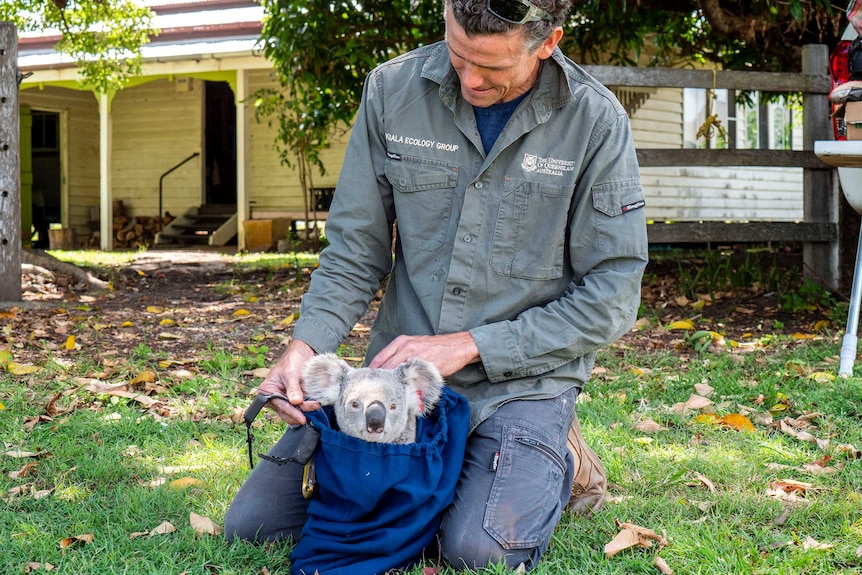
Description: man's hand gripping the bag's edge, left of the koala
258,339,320,425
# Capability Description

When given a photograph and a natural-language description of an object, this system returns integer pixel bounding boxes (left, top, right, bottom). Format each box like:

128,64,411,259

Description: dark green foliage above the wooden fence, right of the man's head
563,0,847,72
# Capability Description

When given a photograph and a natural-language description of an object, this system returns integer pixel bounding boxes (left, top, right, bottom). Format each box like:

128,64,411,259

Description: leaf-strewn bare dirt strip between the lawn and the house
0,250,843,374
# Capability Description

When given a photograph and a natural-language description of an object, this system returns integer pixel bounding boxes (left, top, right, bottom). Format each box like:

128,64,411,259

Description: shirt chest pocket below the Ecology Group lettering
385,156,458,251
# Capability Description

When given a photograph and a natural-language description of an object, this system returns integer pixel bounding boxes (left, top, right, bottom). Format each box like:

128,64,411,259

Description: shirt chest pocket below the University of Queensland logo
491,178,571,280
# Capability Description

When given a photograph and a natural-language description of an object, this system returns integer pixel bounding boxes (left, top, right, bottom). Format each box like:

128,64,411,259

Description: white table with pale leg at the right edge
814,140,862,377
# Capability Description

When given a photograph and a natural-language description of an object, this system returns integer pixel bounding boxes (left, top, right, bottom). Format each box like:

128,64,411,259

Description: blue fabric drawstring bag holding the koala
290,387,470,575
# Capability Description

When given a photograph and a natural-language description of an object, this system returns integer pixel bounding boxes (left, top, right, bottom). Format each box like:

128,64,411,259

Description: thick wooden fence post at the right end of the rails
802,44,841,291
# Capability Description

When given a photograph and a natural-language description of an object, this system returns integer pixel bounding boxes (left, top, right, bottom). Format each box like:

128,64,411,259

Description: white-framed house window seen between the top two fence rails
683,88,802,150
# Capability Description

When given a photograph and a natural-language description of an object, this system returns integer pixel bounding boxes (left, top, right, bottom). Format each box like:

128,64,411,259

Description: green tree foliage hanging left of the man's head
252,0,442,227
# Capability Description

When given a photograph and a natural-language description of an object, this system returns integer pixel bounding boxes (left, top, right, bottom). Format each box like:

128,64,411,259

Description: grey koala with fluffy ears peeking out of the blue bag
302,353,445,443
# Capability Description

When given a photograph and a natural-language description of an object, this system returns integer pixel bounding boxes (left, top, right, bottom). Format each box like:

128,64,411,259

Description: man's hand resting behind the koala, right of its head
368,331,480,377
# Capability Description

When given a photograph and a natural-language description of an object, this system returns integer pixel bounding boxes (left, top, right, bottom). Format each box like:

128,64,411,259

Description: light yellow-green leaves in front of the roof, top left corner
0,0,154,93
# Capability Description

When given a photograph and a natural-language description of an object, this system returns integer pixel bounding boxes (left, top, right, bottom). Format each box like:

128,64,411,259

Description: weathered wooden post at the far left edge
0,22,21,302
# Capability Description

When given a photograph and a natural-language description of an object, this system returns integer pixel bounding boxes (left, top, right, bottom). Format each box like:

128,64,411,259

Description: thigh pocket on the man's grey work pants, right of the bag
483,425,566,549
